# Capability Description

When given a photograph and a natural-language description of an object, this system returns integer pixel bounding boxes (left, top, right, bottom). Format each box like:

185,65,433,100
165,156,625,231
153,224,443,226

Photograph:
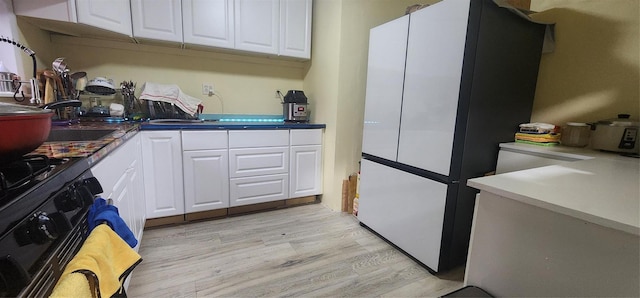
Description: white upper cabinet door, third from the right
182,0,235,49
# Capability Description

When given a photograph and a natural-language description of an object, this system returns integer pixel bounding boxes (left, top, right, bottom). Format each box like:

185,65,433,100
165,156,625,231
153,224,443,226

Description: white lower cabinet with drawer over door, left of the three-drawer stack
182,130,229,213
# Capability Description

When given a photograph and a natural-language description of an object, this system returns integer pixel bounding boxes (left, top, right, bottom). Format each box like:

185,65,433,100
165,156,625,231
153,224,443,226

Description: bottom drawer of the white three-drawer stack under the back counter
229,174,289,207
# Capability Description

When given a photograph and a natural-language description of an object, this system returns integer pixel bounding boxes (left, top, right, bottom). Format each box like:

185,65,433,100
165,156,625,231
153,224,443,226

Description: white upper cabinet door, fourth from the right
131,0,182,43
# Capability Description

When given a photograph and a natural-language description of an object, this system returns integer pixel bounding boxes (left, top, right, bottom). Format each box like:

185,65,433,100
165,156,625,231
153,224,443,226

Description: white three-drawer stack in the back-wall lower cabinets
229,130,289,207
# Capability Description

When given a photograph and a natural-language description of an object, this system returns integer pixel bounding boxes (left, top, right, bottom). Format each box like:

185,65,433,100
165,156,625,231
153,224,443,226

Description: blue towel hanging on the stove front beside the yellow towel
87,198,138,248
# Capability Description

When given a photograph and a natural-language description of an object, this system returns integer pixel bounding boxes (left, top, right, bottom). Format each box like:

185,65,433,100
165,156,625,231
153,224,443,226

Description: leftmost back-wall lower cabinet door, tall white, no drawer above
142,131,184,218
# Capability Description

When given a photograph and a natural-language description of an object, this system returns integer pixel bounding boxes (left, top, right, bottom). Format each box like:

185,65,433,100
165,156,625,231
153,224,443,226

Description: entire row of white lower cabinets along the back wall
141,129,322,218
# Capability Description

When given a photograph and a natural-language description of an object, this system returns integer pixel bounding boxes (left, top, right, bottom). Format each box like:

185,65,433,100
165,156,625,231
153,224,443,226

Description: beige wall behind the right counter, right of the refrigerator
531,0,640,125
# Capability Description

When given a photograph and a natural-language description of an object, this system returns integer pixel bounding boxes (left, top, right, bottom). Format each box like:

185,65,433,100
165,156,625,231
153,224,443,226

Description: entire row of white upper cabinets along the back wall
13,0,312,59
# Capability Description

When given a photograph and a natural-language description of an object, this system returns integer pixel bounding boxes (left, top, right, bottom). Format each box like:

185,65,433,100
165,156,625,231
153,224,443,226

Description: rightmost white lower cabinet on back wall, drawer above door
289,129,322,198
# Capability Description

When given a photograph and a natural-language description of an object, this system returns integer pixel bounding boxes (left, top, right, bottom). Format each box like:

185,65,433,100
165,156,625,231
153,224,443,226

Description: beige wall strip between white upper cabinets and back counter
34,35,308,114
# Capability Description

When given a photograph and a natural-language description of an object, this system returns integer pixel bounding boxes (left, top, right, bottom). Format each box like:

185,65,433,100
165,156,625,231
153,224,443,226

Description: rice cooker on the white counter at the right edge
591,114,640,154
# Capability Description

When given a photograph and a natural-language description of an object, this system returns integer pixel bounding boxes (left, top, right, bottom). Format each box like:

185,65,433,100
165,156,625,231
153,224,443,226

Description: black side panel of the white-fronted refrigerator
442,0,545,266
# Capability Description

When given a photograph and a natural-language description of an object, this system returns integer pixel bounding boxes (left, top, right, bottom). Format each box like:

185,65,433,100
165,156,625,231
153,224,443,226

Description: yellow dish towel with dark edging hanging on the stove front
54,224,142,297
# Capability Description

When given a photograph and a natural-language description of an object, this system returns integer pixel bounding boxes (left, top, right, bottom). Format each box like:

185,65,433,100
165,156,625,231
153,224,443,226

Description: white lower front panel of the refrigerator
358,159,447,271
